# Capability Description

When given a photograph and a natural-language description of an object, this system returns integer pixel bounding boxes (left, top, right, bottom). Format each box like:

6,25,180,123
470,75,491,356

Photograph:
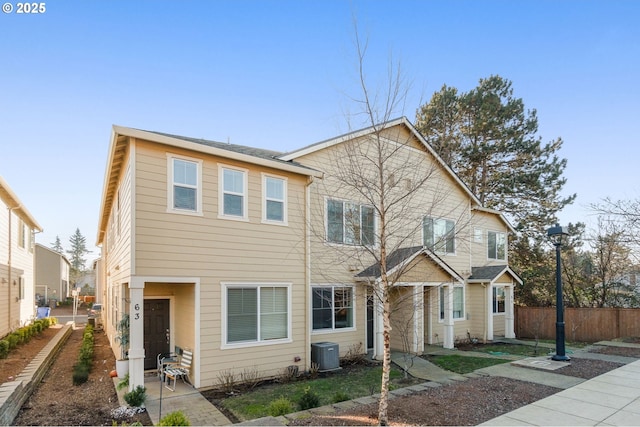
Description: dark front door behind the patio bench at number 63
144,299,170,369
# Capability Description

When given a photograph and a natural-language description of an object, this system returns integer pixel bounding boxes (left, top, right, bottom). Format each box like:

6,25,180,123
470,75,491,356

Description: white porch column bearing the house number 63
129,277,144,391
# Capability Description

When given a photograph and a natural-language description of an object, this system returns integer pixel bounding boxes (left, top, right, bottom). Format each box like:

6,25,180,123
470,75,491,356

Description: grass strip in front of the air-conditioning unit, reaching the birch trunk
222,366,404,421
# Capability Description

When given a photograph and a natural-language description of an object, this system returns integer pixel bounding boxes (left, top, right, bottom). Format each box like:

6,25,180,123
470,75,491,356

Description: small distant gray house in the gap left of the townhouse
34,243,72,305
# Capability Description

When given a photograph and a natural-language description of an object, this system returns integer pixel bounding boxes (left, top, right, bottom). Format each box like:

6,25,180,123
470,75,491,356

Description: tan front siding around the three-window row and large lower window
125,140,309,387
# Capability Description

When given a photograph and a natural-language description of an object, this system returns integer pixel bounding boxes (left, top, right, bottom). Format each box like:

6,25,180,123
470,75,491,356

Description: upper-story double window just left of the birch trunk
327,199,376,246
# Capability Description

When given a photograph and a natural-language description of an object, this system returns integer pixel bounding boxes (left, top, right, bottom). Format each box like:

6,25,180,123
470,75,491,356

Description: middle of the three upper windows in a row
218,165,248,221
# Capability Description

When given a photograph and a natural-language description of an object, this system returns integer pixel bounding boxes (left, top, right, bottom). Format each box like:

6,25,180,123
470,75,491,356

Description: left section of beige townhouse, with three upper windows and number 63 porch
96,126,322,388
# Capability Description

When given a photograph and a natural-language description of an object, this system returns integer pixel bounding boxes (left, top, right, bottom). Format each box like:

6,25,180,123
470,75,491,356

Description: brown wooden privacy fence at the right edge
514,306,640,342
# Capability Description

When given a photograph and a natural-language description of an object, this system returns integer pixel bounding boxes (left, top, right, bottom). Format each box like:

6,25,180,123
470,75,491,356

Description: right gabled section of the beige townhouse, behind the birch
280,118,521,358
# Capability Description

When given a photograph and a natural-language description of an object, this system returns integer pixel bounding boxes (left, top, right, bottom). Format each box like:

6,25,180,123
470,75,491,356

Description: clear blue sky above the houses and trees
0,0,640,258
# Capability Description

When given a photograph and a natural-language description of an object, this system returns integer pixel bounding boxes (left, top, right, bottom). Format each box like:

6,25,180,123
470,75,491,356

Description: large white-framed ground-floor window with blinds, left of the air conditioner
222,283,291,347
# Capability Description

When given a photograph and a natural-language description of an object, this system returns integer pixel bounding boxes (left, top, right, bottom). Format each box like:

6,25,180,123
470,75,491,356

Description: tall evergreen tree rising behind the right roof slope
416,76,575,239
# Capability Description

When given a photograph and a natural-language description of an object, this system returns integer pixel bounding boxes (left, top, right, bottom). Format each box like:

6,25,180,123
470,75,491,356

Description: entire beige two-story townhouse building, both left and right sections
96,118,520,388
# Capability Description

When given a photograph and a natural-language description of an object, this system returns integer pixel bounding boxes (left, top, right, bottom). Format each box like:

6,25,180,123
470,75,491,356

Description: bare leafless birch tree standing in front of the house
304,30,469,425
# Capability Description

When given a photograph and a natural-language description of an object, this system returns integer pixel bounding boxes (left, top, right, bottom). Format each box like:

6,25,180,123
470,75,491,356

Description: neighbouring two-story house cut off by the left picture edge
0,177,42,337
